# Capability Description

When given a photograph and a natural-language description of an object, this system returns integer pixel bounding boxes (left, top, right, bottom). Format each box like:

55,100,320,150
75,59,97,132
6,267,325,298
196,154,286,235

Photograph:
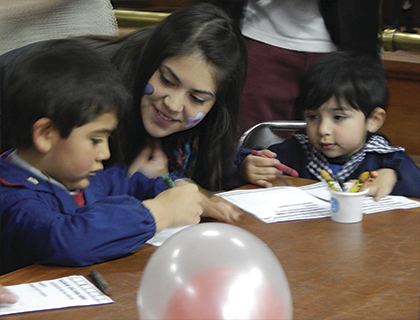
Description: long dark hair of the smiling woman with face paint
113,3,247,190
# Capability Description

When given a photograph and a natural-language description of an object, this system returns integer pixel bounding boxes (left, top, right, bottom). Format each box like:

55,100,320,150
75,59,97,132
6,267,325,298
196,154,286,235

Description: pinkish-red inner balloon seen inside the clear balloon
163,267,287,320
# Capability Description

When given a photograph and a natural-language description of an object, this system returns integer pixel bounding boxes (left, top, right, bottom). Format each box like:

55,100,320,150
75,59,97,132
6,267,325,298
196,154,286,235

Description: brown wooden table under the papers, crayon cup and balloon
0,178,420,320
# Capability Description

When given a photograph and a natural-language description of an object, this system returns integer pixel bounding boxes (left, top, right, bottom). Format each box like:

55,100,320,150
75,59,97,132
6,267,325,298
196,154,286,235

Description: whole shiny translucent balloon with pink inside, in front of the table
137,223,292,320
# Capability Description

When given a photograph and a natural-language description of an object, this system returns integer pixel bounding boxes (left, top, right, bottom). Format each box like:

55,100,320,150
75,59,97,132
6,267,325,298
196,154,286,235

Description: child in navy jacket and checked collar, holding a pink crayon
238,52,420,200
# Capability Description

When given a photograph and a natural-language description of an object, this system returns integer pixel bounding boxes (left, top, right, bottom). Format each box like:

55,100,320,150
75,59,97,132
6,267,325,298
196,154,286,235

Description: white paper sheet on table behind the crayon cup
217,182,420,223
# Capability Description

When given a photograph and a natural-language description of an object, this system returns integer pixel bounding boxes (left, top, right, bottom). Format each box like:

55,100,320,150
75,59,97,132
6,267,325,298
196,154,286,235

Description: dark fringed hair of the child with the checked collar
295,51,388,119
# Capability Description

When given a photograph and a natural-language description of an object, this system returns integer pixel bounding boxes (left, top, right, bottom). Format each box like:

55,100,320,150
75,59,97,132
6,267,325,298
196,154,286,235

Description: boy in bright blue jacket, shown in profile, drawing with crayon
0,40,203,274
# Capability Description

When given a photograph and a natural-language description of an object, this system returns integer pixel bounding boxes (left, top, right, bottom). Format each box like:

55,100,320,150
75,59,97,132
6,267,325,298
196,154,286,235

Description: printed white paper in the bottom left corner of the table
0,276,114,316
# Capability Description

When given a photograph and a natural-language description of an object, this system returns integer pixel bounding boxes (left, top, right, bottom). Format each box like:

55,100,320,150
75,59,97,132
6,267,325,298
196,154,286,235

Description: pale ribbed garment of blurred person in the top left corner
0,0,118,55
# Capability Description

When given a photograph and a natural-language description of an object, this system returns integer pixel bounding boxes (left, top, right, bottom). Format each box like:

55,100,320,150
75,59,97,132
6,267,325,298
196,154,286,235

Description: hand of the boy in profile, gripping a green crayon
143,181,207,232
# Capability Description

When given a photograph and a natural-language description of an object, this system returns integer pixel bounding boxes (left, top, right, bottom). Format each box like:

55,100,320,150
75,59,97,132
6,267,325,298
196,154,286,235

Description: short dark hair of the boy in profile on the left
5,39,131,148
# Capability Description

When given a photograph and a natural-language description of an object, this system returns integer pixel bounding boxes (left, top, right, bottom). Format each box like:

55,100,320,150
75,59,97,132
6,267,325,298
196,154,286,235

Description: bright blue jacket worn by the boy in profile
0,152,167,274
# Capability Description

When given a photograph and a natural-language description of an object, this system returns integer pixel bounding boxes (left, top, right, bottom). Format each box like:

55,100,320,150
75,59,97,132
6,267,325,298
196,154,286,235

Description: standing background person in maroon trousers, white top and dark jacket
198,0,380,133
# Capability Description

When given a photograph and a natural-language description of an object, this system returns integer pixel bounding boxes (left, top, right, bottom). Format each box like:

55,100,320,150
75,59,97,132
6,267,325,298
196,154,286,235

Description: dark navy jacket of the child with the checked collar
235,136,420,198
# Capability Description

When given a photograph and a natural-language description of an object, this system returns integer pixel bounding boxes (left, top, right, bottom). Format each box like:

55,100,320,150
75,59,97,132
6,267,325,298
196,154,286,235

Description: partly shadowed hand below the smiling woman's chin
127,140,168,179
